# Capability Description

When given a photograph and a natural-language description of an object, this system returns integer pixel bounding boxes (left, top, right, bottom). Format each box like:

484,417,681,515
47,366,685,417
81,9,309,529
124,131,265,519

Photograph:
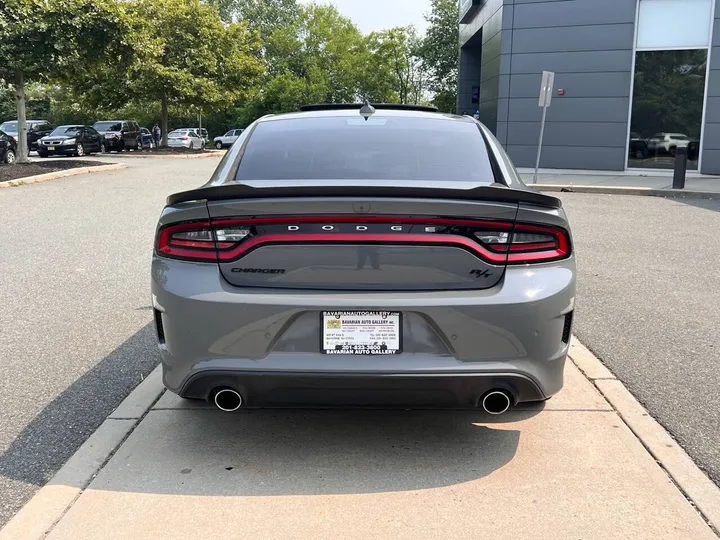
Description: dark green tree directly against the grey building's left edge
420,0,460,112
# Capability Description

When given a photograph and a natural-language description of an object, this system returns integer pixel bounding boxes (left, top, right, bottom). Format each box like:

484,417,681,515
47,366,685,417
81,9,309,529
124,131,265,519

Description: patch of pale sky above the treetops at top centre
303,0,430,34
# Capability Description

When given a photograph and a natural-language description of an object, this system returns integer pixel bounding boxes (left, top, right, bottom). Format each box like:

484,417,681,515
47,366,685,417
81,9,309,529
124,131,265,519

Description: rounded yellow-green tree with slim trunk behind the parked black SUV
123,0,263,144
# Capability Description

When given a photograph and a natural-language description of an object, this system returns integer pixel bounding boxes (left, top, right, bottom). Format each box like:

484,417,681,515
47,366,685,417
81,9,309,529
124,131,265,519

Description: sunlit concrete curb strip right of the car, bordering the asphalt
568,336,720,534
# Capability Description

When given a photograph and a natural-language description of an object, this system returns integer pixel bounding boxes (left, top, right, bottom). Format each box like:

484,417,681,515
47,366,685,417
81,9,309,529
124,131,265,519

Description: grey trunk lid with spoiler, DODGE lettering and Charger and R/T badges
187,181,557,291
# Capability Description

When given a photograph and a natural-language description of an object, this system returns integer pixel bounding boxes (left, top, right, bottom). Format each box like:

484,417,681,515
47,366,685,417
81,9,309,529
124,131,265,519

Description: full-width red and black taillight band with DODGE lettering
157,216,571,265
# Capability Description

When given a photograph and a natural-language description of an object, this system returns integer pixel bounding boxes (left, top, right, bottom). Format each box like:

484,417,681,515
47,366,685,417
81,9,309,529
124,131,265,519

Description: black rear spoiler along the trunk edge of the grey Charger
167,184,562,208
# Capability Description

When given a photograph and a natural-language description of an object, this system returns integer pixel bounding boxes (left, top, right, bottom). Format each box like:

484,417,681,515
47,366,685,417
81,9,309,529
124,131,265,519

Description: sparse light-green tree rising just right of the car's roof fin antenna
367,26,426,105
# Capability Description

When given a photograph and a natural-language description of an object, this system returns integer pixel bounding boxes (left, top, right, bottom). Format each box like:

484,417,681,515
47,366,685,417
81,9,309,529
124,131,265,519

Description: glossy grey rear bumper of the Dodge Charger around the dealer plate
152,257,575,405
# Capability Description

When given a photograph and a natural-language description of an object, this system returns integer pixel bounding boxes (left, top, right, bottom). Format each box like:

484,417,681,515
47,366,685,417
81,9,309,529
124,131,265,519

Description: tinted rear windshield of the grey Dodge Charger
236,115,494,184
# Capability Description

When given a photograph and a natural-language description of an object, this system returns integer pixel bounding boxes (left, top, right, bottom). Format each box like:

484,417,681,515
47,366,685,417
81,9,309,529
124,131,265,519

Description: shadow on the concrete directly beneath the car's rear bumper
86,408,541,496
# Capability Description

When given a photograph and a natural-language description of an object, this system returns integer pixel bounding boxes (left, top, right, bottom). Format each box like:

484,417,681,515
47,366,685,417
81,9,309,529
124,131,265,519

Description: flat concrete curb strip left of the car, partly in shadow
0,366,165,540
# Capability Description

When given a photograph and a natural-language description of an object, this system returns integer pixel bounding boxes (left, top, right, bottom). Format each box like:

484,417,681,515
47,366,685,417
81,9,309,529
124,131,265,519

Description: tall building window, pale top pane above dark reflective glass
628,0,712,170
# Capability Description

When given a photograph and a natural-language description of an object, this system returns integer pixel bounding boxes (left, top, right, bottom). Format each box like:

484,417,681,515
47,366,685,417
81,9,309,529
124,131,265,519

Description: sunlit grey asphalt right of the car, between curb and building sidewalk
562,194,720,484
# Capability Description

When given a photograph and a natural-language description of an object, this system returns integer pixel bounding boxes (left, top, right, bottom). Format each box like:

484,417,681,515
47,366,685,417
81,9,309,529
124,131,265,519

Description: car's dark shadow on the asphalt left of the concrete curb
0,324,160,486
